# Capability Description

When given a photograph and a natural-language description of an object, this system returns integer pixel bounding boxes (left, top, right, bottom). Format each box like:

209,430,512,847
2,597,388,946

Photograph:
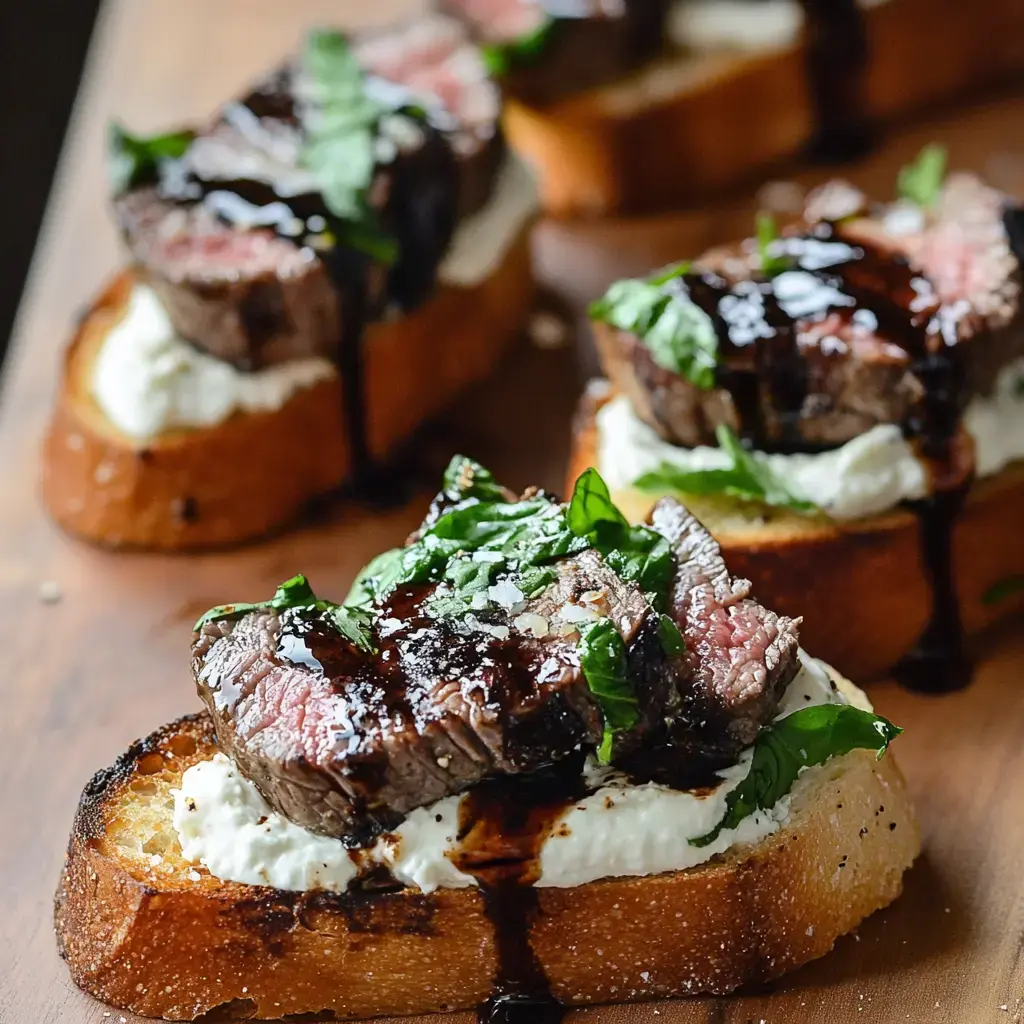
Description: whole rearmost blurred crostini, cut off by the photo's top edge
446,0,1024,215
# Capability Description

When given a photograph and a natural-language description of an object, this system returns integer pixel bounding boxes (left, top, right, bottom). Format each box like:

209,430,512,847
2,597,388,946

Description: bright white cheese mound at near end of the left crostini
91,285,336,440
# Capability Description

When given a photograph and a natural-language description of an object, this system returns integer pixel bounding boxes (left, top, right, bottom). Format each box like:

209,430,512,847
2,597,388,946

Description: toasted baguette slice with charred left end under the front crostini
55,677,920,1020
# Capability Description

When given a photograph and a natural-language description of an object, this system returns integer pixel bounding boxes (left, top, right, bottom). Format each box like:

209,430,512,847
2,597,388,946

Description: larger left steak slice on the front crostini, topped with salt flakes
194,551,656,845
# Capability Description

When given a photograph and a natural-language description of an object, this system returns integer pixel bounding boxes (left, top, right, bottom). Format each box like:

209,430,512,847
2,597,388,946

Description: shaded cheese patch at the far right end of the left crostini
437,157,540,288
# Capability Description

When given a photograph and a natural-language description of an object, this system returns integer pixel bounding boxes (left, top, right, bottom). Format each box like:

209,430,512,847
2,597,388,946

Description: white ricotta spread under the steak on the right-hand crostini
597,359,1024,520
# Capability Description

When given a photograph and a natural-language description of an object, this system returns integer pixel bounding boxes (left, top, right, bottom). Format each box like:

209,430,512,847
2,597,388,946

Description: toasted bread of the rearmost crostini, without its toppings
505,0,1024,216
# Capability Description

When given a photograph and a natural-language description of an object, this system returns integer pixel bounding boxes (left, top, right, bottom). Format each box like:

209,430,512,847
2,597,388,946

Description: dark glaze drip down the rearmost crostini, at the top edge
802,0,873,161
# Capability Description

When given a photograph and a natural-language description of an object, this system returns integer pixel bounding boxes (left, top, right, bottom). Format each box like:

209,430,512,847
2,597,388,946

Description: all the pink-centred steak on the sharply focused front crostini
193,500,798,845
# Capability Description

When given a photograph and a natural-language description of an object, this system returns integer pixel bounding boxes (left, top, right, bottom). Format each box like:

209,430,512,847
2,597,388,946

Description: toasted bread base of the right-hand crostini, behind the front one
567,389,1024,681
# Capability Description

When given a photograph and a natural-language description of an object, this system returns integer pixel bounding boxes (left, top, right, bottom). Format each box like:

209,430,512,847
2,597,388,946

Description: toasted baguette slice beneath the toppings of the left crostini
42,226,534,551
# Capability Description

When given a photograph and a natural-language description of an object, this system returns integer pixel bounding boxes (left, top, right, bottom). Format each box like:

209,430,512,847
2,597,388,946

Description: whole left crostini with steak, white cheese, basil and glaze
43,14,537,550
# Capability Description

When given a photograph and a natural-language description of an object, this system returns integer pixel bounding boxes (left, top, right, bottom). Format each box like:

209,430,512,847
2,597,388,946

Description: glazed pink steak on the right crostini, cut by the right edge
596,175,1024,451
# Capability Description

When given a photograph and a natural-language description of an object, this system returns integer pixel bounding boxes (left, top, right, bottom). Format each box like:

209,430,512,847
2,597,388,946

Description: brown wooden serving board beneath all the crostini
0,0,1024,1024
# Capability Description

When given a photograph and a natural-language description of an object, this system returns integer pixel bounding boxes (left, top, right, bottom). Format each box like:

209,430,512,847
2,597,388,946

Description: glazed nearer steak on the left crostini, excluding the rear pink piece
115,51,459,369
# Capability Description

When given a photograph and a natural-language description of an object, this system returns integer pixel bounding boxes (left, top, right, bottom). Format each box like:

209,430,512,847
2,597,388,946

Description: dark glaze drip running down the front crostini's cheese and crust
453,758,587,1024
